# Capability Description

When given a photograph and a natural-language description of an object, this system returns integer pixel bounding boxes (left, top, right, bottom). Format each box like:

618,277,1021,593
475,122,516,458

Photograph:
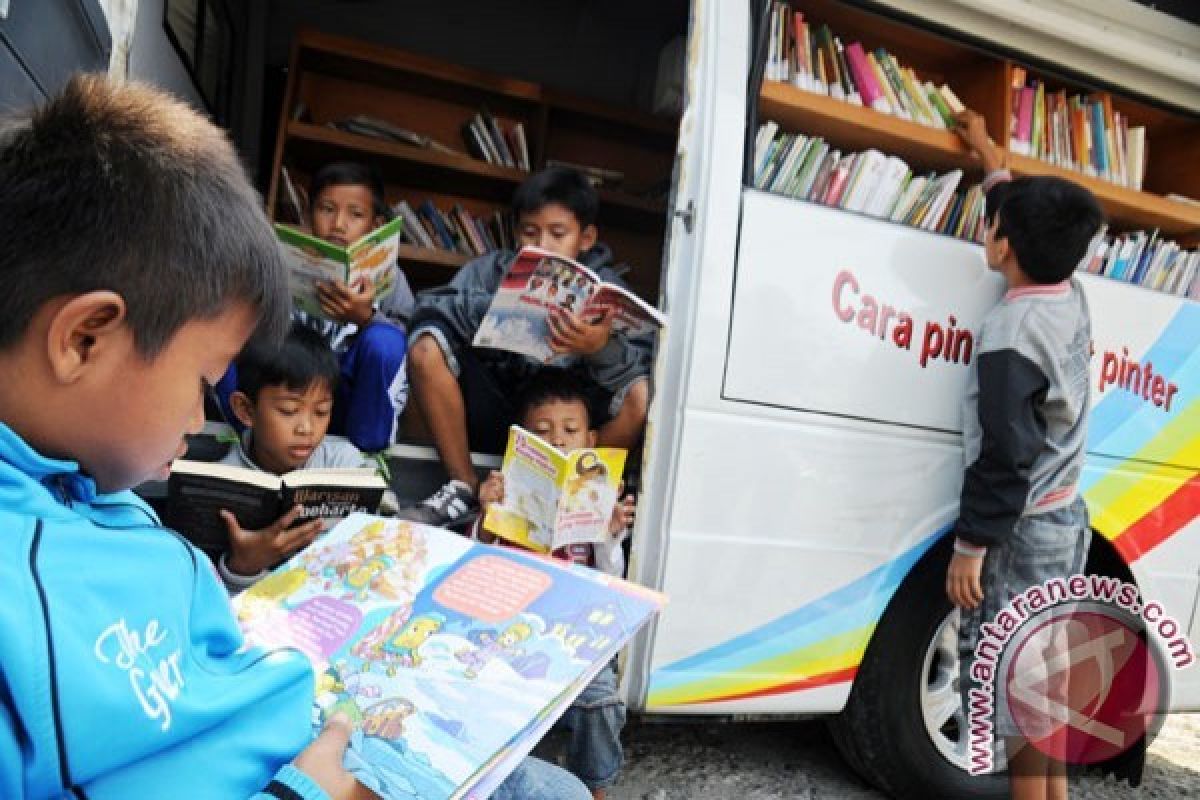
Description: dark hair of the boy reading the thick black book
238,323,338,402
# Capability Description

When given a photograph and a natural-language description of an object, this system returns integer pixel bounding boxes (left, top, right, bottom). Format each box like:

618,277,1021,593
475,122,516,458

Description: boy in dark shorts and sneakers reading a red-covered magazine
401,168,653,525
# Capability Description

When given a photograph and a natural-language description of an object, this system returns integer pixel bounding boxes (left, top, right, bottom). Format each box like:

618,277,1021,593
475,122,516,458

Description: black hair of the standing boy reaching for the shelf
985,176,1104,283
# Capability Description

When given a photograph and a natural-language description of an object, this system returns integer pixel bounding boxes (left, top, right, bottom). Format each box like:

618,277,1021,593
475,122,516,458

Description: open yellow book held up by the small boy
484,425,625,553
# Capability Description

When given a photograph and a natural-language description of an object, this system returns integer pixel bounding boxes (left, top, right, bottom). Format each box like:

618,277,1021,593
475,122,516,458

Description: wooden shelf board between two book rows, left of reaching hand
758,80,980,172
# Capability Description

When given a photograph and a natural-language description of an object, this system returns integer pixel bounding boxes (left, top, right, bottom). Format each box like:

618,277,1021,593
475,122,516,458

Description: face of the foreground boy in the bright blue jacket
88,303,258,492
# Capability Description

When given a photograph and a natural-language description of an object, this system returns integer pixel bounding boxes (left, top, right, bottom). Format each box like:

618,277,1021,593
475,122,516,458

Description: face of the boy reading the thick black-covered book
233,380,334,475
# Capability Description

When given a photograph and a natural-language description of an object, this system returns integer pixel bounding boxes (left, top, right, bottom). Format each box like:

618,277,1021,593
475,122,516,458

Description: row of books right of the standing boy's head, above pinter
1079,225,1200,300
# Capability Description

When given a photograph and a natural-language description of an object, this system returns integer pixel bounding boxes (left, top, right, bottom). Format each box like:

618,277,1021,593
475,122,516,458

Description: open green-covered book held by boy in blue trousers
275,217,404,317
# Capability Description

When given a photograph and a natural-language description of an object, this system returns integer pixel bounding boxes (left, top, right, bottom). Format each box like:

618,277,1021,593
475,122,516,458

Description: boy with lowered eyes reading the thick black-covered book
217,323,372,591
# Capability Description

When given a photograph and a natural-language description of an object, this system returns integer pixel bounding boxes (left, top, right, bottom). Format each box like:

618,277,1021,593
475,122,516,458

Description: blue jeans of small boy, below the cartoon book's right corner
559,662,625,789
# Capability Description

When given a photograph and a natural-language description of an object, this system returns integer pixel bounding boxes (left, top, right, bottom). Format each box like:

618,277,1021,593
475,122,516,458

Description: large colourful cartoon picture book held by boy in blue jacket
234,515,665,800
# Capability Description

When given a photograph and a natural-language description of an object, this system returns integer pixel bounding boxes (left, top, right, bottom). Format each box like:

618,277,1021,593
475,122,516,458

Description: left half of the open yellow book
484,425,565,553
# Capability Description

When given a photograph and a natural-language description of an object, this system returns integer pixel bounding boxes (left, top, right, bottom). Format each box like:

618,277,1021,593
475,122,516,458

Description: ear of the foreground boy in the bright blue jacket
46,291,133,384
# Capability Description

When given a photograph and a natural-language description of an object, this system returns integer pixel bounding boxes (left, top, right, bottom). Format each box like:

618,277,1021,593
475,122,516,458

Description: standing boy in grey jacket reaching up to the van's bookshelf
946,112,1103,800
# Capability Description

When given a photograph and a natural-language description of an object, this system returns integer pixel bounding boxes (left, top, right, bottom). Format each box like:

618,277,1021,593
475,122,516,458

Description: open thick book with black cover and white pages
163,458,388,552
